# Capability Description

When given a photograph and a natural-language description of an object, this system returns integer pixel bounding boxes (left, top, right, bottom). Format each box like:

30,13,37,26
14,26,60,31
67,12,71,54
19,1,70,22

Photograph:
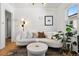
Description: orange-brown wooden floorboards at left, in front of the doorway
0,41,17,56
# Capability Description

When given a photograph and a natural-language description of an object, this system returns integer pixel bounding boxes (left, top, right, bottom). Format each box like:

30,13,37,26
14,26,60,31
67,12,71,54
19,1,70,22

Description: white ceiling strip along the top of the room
10,3,61,8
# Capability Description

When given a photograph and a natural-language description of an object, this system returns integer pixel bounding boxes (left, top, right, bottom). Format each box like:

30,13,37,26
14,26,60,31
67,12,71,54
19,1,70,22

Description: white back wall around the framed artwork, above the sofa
15,7,56,36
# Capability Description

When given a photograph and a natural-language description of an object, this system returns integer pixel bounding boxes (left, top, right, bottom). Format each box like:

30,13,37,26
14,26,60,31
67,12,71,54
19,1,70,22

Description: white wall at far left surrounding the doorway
0,3,14,49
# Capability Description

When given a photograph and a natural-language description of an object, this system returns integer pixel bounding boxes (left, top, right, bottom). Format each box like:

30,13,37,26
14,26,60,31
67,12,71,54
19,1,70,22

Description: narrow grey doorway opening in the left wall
5,10,11,42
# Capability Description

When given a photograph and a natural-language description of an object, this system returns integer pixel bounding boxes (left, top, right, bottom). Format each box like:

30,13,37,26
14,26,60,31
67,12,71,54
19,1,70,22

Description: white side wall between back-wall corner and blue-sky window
56,3,70,32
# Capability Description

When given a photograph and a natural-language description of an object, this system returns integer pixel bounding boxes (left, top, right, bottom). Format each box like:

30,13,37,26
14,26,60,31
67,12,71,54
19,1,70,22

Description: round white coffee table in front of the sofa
27,42,48,56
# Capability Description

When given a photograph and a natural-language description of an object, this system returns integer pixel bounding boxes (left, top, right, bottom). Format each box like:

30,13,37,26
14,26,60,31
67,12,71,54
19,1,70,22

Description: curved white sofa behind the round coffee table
16,36,63,48
